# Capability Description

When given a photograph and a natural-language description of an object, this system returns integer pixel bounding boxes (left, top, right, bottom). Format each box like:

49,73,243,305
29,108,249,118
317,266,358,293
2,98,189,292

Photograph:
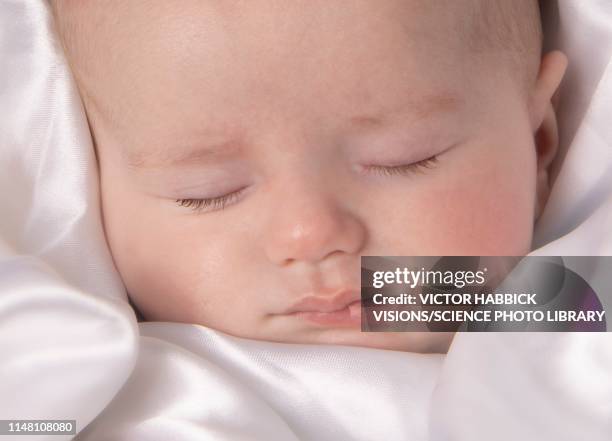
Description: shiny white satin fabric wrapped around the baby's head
0,0,612,441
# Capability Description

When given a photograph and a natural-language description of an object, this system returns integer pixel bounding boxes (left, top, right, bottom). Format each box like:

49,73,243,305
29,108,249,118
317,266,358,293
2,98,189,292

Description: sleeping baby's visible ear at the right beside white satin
529,51,567,219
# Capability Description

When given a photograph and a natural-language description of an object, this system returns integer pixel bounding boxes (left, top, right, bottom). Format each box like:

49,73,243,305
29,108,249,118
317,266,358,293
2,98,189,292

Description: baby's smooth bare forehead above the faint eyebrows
55,0,528,143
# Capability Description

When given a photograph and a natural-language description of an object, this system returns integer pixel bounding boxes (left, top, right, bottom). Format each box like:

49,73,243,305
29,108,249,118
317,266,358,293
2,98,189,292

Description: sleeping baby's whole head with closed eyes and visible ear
54,0,566,351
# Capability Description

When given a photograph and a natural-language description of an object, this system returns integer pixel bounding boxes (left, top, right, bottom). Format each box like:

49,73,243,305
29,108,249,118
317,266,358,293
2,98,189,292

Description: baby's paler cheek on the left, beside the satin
107,192,252,326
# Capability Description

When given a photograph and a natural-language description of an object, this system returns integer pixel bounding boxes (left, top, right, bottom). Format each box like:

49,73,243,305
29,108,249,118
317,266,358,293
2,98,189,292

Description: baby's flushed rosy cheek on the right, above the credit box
380,144,535,256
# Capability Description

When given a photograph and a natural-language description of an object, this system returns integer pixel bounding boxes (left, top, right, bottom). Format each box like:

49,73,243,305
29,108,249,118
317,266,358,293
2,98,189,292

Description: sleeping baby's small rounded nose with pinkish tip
265,188,366,266
